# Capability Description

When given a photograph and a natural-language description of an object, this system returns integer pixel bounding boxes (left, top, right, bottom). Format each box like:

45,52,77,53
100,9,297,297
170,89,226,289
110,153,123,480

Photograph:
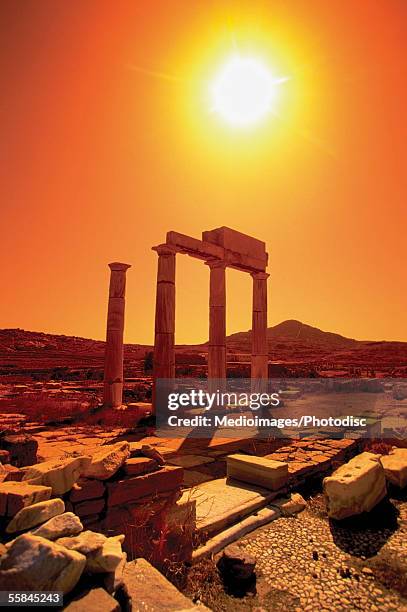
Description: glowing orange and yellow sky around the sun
0,0,407,343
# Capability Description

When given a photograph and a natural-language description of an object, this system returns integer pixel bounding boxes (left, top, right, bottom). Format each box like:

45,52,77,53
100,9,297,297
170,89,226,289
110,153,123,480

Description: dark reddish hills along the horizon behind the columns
0,320,407,370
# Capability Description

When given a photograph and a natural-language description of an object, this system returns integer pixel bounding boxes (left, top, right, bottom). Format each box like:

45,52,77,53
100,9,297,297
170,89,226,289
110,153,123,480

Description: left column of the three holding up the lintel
153,244,177,410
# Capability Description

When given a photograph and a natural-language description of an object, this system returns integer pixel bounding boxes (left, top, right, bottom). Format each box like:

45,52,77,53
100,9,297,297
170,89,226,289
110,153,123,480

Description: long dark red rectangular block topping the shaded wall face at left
107,466,184,507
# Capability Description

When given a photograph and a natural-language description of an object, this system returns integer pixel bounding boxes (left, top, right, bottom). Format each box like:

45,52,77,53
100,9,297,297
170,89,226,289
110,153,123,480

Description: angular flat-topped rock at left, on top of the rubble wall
23,456,91,495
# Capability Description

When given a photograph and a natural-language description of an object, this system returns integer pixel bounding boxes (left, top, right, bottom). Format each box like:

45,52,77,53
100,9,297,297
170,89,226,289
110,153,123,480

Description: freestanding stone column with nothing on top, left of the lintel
103,262,130,408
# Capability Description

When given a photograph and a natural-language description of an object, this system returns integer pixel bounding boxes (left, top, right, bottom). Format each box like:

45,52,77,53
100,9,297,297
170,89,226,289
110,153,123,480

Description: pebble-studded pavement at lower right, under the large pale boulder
240,496,407,612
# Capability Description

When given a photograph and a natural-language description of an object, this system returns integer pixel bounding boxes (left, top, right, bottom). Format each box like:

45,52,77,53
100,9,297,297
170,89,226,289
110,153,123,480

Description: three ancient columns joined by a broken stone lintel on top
153,227,269,408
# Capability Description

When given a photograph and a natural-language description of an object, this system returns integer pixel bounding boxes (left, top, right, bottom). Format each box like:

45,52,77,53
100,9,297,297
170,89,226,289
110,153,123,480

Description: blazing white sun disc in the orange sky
211,56,279,126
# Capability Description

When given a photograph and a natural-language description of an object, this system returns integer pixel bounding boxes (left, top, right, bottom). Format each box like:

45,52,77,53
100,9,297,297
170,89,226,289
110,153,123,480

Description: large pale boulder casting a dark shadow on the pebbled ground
323,452,387,519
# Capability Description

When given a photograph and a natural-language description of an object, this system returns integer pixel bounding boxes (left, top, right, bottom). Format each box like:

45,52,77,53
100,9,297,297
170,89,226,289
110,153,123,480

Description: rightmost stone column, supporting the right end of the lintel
251,272,269,379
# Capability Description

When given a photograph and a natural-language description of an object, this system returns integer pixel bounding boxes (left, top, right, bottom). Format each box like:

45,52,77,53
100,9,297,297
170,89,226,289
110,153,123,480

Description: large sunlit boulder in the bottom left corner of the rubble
0,533,86,594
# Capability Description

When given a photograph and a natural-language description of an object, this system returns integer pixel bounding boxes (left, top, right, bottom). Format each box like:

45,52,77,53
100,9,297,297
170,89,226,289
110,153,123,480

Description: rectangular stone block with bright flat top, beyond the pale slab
226,455,288,491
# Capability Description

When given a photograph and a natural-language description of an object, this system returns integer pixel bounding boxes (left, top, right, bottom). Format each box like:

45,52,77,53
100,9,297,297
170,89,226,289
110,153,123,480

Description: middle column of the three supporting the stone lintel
205,260,226,379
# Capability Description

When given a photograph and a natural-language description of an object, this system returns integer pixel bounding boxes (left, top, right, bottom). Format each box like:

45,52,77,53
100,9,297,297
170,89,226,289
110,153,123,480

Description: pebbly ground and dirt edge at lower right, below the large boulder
189,494,407,612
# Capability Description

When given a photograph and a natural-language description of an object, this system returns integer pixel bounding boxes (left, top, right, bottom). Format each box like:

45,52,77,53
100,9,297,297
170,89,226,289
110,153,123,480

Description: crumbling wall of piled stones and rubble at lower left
0,441,199,612
